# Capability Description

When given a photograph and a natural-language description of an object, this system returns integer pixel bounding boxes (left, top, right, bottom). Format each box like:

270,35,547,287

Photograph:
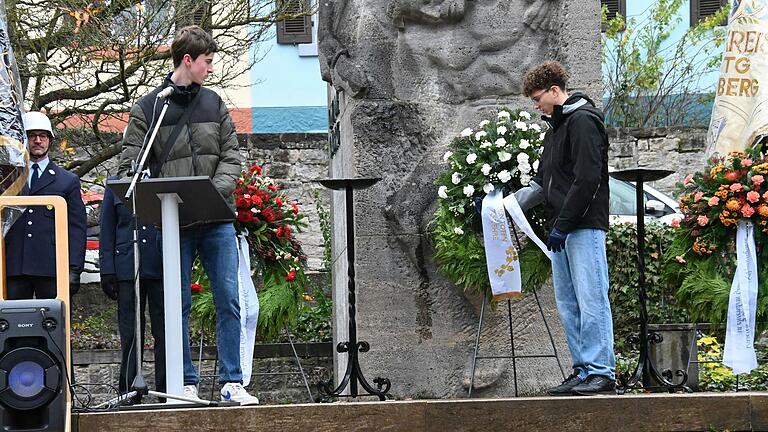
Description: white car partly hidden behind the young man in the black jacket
609,177,683,224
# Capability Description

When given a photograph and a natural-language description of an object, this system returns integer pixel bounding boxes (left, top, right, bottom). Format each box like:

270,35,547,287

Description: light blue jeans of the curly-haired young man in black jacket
552,229,616,379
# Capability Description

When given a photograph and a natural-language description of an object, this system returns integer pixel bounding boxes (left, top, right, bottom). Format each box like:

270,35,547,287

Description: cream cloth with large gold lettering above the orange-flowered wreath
707,0,768,155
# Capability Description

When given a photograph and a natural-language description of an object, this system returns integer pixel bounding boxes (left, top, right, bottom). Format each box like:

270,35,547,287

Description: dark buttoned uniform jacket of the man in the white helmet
5,161,86,277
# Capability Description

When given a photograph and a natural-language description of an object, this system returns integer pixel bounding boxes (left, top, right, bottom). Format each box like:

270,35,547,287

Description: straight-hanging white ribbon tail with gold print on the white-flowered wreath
481,191,523,301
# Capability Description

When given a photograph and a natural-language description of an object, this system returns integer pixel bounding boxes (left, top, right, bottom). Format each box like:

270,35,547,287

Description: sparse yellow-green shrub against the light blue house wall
602,0,730,127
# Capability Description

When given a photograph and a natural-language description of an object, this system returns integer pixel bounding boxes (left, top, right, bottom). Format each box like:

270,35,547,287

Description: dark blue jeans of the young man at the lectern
179,223,243,385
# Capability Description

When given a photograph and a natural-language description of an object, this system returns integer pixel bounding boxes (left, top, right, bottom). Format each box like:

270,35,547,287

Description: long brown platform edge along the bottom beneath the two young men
73,392,768,432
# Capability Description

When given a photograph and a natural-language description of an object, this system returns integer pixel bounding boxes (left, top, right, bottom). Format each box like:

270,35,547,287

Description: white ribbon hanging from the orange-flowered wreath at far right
723,220,757,374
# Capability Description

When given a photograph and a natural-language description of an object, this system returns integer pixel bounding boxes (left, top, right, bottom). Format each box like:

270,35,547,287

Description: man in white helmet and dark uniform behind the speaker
5,112,86,300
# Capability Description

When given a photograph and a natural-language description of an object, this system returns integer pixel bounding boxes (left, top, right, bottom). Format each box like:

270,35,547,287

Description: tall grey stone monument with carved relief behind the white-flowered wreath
318,0,602,399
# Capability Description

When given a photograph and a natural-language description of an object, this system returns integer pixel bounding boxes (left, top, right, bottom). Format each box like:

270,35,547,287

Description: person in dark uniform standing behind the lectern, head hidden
99,177,165,402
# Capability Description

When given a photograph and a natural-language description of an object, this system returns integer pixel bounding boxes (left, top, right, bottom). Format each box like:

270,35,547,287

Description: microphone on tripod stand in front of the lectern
96,97,221,408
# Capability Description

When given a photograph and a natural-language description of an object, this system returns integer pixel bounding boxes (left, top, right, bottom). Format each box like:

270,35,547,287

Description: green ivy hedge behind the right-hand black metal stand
606,223,690,351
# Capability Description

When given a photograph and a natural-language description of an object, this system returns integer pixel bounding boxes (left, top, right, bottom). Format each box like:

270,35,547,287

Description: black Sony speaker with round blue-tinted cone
0,299,69,432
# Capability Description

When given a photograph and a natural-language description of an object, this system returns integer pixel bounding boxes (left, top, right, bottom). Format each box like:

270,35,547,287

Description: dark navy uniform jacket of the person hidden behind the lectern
99,177,163,281
